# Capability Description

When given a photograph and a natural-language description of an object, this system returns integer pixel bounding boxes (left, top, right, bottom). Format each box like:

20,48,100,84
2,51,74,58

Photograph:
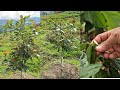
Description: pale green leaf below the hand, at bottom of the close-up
80,64,102,78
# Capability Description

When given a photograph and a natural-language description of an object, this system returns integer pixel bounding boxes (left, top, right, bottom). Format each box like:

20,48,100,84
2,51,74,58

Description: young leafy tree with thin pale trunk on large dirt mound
47,17,77,75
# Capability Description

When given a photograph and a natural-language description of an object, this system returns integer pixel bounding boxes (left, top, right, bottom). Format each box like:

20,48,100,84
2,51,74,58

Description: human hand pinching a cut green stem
93,27,120,59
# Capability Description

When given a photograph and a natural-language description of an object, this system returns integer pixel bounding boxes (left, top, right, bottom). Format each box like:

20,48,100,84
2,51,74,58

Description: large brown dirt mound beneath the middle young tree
41,64,80,79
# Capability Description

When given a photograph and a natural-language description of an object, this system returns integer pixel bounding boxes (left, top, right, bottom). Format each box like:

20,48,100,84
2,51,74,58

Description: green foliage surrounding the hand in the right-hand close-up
80,11,120,78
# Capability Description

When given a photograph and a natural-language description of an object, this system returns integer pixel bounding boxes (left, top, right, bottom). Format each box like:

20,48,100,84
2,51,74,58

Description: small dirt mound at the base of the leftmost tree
11,72,37,79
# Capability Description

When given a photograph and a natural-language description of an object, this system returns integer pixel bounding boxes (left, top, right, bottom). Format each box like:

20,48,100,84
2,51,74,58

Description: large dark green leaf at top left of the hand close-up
81,11,107,31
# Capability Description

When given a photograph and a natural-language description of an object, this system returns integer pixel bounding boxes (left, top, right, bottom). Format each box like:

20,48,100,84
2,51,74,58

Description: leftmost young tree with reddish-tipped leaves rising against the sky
3,15,40,78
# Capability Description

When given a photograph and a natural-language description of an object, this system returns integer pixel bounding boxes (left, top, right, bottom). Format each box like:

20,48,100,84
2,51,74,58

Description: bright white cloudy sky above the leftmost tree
0,11,40,19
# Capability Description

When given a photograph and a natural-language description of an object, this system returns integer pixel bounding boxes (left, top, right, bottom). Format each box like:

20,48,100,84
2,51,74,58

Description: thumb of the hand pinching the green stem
96,35,116,52
